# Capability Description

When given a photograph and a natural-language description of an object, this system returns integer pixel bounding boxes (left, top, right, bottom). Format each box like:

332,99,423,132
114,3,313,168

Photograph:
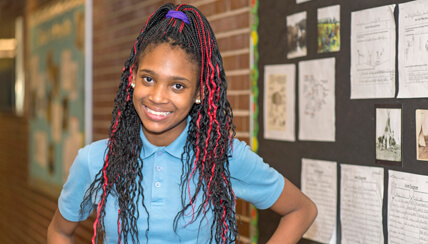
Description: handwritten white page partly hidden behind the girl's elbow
301,158,337,243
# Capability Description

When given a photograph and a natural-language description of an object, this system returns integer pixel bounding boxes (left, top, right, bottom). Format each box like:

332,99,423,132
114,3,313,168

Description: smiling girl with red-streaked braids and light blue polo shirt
48,4,316,243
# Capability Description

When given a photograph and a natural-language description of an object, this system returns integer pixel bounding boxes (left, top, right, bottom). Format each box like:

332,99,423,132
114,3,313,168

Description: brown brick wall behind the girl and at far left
0,0,250,243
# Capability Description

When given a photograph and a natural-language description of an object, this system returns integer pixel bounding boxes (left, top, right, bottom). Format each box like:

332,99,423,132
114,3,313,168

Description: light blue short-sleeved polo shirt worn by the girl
58,121,284,244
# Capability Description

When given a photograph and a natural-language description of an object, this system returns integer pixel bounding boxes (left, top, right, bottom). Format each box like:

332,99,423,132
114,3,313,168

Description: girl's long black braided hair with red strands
81,4,238,243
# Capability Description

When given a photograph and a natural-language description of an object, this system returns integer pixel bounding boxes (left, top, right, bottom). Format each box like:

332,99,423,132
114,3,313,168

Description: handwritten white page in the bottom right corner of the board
388,170,428,244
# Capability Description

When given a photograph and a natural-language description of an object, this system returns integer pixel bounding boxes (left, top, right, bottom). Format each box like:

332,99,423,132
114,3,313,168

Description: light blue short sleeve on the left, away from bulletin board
58,145,93,222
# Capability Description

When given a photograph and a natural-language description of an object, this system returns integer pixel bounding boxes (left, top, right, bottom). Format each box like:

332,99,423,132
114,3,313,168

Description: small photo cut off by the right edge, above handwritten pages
416,109,428,161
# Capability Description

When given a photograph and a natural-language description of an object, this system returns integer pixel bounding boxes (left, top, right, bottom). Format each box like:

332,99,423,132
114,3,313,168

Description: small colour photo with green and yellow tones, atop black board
317,5,340,53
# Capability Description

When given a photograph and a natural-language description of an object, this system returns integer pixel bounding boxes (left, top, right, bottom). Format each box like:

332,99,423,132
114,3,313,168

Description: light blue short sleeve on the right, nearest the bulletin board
229,139,284,209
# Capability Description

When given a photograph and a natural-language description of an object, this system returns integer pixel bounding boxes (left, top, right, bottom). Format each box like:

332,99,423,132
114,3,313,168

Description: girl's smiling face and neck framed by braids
133,43,199,146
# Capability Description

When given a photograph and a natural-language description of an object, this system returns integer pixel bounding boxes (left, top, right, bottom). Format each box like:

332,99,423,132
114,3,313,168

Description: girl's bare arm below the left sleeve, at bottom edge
48,209,79,244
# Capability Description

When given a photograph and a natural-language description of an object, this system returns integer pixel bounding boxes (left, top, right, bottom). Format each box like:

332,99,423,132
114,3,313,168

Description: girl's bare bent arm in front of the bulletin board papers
268,179,317,244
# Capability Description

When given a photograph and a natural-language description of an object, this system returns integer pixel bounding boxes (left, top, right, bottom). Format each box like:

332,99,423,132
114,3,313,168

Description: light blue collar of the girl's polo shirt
140,116,190,159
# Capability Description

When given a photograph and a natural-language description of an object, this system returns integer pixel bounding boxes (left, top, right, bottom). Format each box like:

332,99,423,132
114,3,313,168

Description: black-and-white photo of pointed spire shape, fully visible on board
376,105,402,165
